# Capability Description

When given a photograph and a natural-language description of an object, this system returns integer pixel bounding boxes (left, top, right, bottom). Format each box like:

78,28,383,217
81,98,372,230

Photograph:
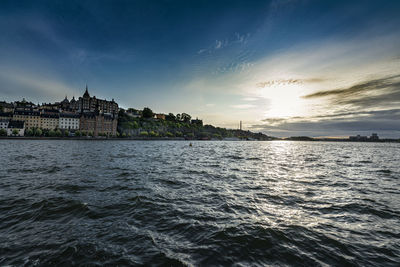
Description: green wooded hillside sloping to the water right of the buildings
118,108,269,140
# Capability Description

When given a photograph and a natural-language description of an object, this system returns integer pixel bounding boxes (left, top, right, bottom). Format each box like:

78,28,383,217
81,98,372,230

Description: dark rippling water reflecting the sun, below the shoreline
0,140,400,266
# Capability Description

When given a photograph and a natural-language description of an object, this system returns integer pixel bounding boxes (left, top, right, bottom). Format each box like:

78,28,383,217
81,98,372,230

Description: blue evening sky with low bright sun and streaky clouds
0,0,400,138
